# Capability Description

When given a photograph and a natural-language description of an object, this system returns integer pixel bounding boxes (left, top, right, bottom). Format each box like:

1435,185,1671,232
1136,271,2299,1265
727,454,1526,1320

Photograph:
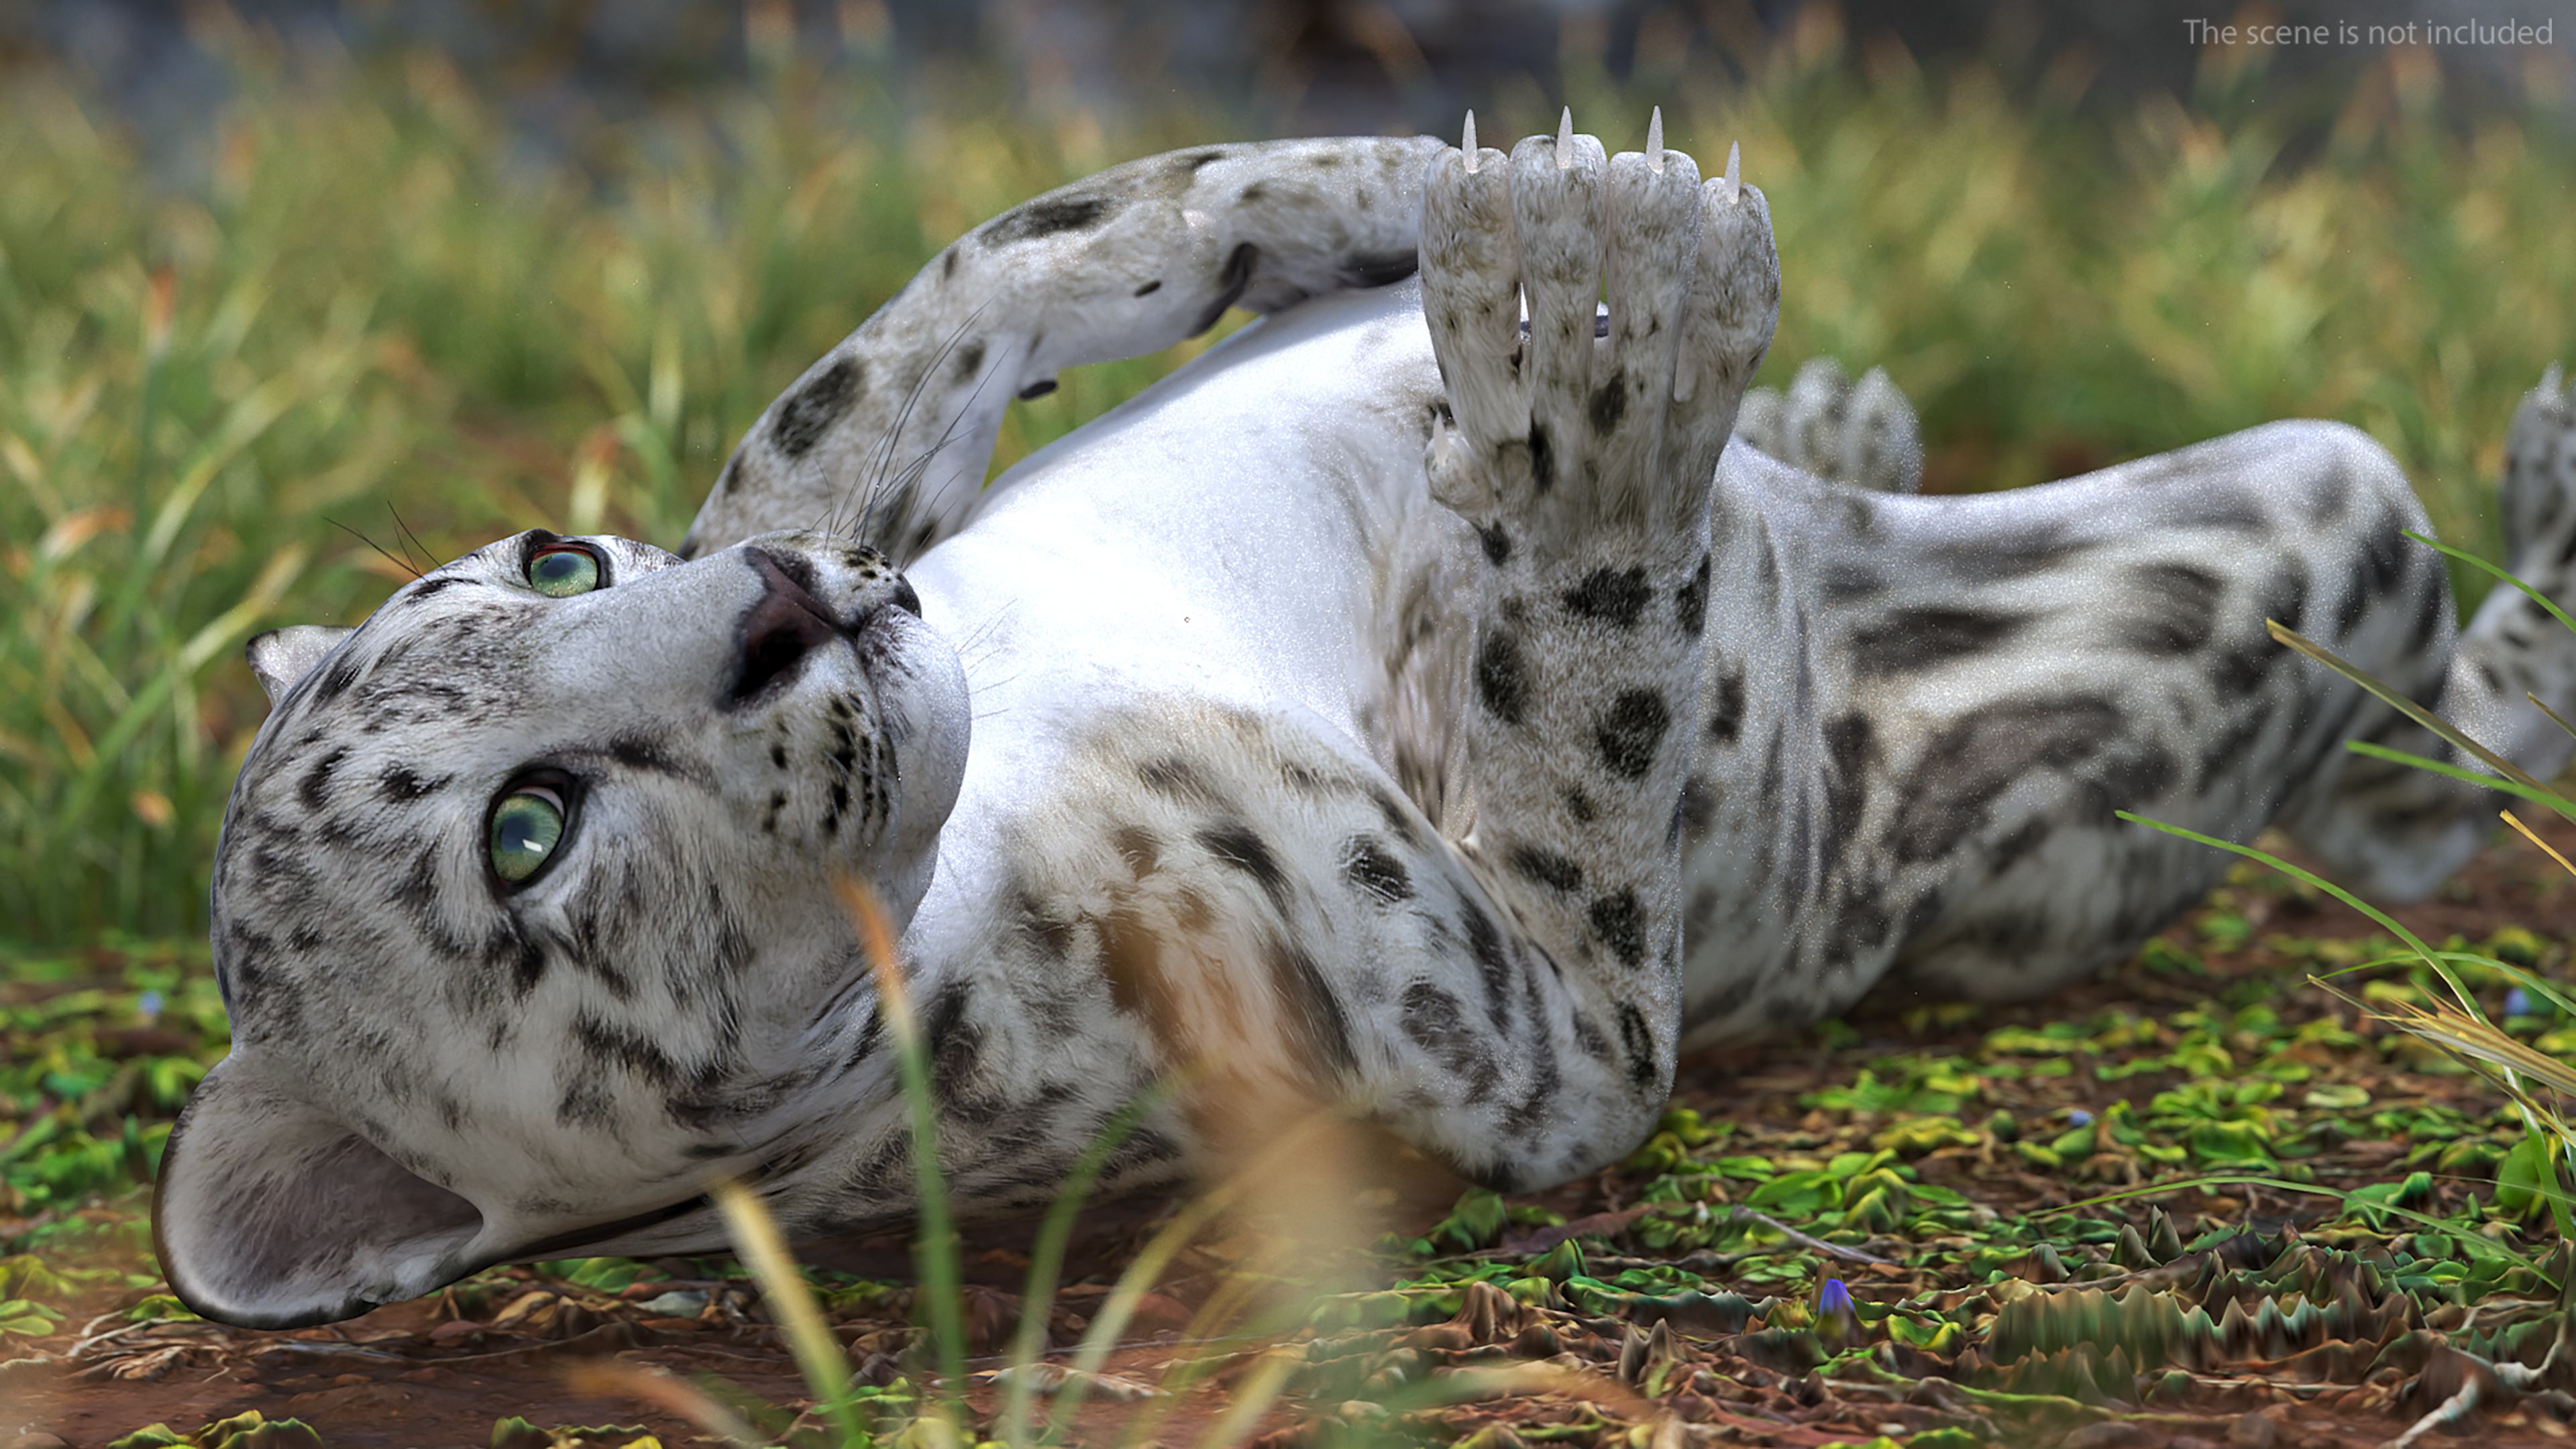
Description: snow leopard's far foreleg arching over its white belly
680,137,1438,565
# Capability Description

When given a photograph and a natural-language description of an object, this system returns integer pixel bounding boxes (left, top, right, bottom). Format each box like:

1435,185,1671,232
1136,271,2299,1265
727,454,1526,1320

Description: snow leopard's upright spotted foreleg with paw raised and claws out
1422,116,1780,1152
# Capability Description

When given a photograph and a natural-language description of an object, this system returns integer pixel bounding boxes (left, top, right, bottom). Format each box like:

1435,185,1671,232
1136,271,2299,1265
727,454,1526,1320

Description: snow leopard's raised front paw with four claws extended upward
1422,111,1780,554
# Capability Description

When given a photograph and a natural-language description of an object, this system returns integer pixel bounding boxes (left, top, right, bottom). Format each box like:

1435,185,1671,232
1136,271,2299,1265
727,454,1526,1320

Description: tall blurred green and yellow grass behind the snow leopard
0,15,2576,947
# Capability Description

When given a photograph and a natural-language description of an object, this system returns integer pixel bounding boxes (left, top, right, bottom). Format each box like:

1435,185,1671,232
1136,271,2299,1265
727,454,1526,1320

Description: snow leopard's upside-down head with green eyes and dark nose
154,531,969,1326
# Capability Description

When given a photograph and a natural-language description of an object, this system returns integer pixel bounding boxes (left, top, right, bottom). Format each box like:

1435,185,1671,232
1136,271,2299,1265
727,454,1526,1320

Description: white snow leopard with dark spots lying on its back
157,131,2576,1326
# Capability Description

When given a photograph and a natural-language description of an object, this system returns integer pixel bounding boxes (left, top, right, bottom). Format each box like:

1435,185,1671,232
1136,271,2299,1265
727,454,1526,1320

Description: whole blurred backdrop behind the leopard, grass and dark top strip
0,0,2576,954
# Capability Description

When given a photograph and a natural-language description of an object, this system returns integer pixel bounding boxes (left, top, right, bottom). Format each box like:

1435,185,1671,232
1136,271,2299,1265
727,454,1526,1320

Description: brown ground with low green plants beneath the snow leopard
0,825,2576,1449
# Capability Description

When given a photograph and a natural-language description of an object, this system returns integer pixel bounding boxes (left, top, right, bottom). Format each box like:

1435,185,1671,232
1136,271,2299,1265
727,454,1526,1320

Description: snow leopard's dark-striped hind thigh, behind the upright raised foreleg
1684,423,2475,1042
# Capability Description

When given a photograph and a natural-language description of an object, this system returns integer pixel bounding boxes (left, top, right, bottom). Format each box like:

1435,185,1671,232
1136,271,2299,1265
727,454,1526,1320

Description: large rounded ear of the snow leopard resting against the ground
152,1052,484,1328
